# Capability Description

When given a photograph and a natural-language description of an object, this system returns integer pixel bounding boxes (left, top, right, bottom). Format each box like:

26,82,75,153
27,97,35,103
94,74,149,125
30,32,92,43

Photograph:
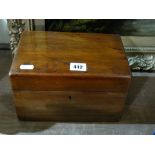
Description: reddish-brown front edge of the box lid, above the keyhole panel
11,74,130,92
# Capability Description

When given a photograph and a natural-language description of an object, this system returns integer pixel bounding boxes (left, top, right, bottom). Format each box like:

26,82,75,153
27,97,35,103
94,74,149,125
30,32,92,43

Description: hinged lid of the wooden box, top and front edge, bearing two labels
10,31,130,91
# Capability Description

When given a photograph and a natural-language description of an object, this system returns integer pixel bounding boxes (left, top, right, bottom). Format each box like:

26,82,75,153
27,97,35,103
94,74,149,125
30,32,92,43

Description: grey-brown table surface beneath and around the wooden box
0,51,155,135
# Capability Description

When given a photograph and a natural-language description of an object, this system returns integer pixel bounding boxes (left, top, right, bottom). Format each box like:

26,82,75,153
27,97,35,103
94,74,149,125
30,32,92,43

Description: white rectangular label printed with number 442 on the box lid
70,63,87,71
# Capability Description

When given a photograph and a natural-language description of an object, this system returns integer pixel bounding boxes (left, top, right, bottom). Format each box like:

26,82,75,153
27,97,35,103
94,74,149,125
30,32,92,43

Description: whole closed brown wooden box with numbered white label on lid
9,32,131,122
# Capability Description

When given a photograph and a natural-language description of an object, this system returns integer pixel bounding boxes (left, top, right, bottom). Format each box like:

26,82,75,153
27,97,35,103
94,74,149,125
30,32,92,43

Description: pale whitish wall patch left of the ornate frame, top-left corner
0,19,9,44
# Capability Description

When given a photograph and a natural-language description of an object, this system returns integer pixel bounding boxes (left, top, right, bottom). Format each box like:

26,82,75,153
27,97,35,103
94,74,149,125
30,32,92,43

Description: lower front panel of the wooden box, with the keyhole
14,91,125,122
